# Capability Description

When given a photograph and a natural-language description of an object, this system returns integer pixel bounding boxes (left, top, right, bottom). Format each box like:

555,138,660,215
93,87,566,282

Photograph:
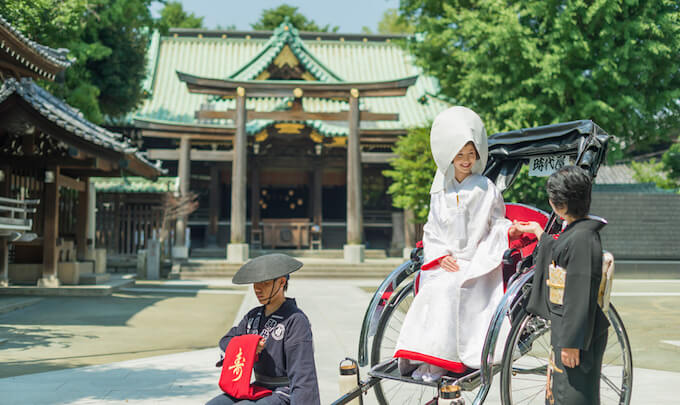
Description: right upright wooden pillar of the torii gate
347,89,364,245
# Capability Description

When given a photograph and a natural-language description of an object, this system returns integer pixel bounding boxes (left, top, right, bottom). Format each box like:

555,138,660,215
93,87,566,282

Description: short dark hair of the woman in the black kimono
545,166,592,218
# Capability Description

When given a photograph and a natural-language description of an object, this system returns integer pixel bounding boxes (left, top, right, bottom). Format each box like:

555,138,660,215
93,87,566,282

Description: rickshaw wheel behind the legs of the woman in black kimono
501,305,633,405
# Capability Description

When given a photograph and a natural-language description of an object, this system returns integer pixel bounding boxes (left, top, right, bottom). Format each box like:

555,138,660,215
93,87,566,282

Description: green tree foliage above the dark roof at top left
0,0,154,123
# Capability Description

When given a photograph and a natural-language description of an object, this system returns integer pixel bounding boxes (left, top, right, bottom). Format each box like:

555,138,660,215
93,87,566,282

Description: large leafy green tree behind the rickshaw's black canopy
400,0,680,156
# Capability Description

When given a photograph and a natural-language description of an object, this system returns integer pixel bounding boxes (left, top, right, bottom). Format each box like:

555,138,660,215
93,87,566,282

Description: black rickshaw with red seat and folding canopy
333,120,633,405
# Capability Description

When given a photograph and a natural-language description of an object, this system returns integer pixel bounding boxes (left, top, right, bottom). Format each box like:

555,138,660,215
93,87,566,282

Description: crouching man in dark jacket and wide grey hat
207,254,320,405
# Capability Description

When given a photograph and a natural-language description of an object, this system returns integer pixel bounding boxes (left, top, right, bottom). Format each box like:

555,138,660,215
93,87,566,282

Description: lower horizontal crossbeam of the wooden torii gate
196,110,399,121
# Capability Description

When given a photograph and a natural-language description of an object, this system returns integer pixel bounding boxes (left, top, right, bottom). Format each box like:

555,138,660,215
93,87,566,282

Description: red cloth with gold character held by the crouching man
219,335,272,400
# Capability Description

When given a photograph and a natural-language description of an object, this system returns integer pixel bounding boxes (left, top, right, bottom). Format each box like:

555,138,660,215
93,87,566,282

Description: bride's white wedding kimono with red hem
395,107,511,372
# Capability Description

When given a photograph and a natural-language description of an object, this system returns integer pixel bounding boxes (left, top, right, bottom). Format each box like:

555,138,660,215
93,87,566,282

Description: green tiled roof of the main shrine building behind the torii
131,23,448,136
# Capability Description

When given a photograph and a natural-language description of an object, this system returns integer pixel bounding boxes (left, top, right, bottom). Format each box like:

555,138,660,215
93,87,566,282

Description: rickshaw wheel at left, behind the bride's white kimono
371,281,479,405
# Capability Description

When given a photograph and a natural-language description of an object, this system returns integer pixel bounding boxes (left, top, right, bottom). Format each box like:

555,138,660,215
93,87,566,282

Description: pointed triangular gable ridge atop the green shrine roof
229,17,344,82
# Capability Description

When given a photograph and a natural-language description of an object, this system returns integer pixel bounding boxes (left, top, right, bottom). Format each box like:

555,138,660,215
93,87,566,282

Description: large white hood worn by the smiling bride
430,106,489,193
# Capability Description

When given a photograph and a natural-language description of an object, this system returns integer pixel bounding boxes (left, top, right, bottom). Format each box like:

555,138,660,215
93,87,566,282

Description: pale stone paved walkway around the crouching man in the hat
0,277,680,405
